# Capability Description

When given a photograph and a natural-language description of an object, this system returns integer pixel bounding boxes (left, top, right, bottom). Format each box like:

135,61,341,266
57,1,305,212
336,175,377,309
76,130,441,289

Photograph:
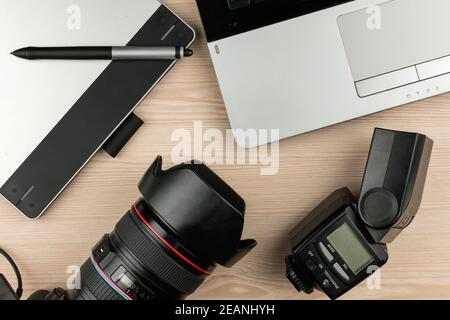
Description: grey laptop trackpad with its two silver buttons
338,0,450,97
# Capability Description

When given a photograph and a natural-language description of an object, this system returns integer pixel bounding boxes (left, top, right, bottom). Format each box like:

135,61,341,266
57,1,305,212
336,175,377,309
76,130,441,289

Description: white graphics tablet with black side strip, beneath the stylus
0,0,194,219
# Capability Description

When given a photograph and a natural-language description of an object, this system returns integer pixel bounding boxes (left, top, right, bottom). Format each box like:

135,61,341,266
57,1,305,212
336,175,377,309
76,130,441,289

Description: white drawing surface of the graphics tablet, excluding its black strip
0,0,161,186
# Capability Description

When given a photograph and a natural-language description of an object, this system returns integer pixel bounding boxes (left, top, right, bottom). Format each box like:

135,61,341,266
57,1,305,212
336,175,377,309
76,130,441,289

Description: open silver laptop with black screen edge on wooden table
197,0,450,147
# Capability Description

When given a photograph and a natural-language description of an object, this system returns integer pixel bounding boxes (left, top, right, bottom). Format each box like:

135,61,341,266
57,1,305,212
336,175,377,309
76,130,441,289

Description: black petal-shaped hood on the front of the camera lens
139,156,256,267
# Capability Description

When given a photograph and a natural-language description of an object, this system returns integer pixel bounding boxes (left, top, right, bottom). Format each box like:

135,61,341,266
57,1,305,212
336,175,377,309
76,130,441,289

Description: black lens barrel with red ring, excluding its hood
74,200,214,300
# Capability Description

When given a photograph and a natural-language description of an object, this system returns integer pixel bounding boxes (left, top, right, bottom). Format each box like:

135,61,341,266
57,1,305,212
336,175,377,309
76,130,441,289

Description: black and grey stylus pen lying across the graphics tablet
11,46,194,60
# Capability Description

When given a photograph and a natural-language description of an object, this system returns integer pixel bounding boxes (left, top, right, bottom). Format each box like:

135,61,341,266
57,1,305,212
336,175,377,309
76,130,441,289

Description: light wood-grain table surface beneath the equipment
0,0,450,299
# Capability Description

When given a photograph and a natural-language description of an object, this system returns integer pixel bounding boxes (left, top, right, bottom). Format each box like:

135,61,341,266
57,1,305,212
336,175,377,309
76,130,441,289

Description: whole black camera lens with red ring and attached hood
69,158,256,300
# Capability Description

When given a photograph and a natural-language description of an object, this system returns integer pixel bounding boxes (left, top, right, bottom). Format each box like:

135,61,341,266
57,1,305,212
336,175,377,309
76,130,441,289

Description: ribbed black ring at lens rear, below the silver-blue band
81,259,124,300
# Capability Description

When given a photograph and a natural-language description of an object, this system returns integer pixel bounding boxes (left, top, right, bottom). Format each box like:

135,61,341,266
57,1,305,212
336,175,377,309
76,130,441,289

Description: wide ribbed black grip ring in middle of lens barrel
116,214,204,294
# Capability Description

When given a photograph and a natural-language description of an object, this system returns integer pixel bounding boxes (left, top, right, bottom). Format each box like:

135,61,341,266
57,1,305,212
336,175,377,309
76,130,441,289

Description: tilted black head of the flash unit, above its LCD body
358,129,433,243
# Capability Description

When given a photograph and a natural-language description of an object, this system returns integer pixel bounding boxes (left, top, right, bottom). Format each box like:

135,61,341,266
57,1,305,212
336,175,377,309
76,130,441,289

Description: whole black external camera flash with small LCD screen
286,129,433,299
